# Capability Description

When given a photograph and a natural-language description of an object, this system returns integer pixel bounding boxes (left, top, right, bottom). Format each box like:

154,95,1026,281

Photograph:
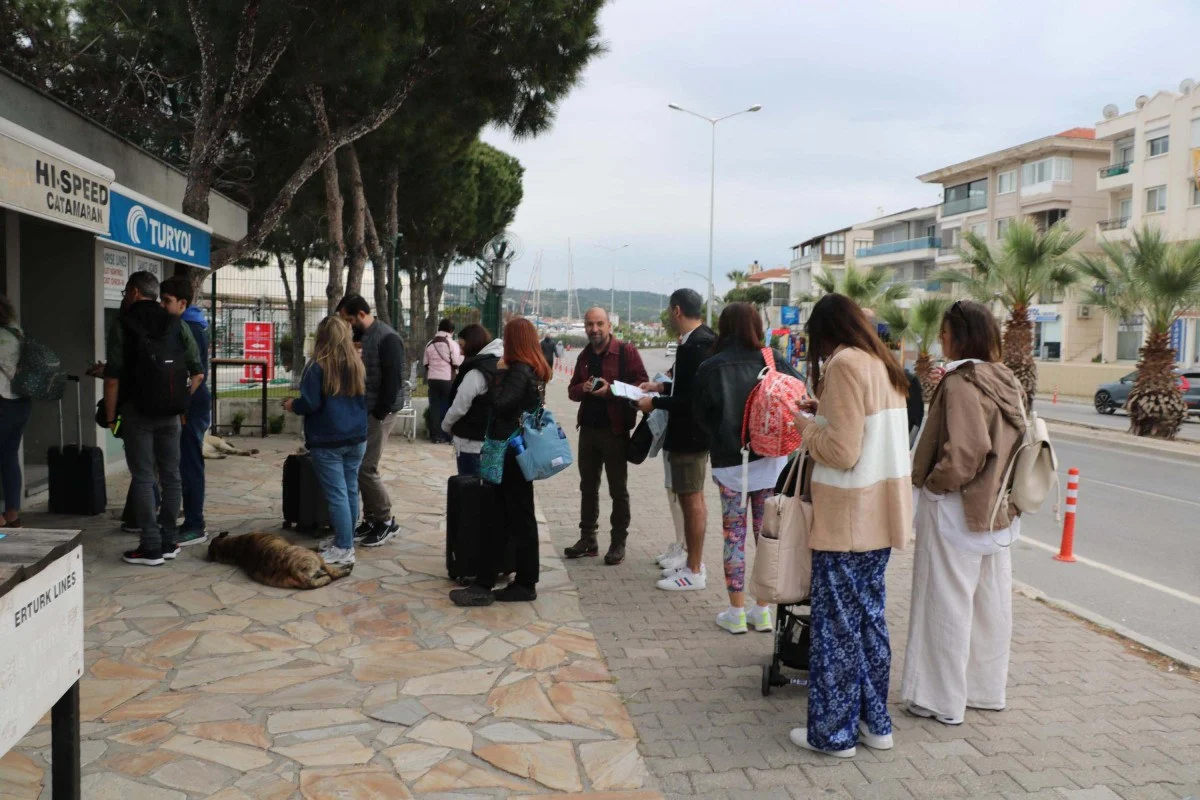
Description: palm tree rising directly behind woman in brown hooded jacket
934,217,1084,407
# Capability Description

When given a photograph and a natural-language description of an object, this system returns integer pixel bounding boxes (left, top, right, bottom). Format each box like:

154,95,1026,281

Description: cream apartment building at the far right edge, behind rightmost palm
1096,80,1200,363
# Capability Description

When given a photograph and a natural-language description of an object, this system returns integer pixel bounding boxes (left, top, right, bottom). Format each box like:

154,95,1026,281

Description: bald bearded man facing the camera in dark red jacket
565,306,647,566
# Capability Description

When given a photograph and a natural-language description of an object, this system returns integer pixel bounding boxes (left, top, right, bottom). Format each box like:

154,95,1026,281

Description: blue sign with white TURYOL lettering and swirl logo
107,186,212,267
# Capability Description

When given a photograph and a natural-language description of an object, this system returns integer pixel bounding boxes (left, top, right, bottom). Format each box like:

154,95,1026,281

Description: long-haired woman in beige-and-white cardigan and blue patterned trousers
791,294,912,758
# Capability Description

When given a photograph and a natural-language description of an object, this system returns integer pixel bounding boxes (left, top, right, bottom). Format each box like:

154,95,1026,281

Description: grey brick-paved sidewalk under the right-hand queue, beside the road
538,376,1200,800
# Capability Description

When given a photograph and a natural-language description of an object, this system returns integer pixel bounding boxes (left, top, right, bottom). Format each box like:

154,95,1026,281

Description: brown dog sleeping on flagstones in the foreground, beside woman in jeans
209,530,354,589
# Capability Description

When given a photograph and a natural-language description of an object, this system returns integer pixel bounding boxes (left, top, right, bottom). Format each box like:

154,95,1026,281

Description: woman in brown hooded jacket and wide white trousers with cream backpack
901,301,1024,726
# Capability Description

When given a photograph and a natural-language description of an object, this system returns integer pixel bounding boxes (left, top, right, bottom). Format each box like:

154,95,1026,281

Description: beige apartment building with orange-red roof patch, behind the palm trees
918,128,1111,361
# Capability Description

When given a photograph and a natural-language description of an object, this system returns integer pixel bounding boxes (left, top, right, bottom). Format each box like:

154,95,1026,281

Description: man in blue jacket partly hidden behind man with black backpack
160,275,212,547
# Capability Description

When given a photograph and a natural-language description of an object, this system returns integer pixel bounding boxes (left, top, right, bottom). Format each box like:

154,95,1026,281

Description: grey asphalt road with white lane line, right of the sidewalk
568,349,1200,658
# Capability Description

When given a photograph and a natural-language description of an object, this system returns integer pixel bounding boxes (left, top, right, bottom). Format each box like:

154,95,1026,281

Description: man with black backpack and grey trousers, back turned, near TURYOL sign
102,271,204,566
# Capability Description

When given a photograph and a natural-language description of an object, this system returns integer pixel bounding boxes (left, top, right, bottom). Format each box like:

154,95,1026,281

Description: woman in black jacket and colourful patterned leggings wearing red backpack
695,302,800,633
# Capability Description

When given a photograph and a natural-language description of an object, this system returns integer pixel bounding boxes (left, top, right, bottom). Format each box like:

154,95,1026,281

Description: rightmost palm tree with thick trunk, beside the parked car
1076,225,1200,439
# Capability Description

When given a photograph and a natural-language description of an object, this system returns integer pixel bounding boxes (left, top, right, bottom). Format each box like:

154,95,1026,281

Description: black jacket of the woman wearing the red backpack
694,345,800,469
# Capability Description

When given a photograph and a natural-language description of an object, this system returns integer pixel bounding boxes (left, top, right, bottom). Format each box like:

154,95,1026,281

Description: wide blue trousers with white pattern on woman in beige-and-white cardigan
808,547,892,750
